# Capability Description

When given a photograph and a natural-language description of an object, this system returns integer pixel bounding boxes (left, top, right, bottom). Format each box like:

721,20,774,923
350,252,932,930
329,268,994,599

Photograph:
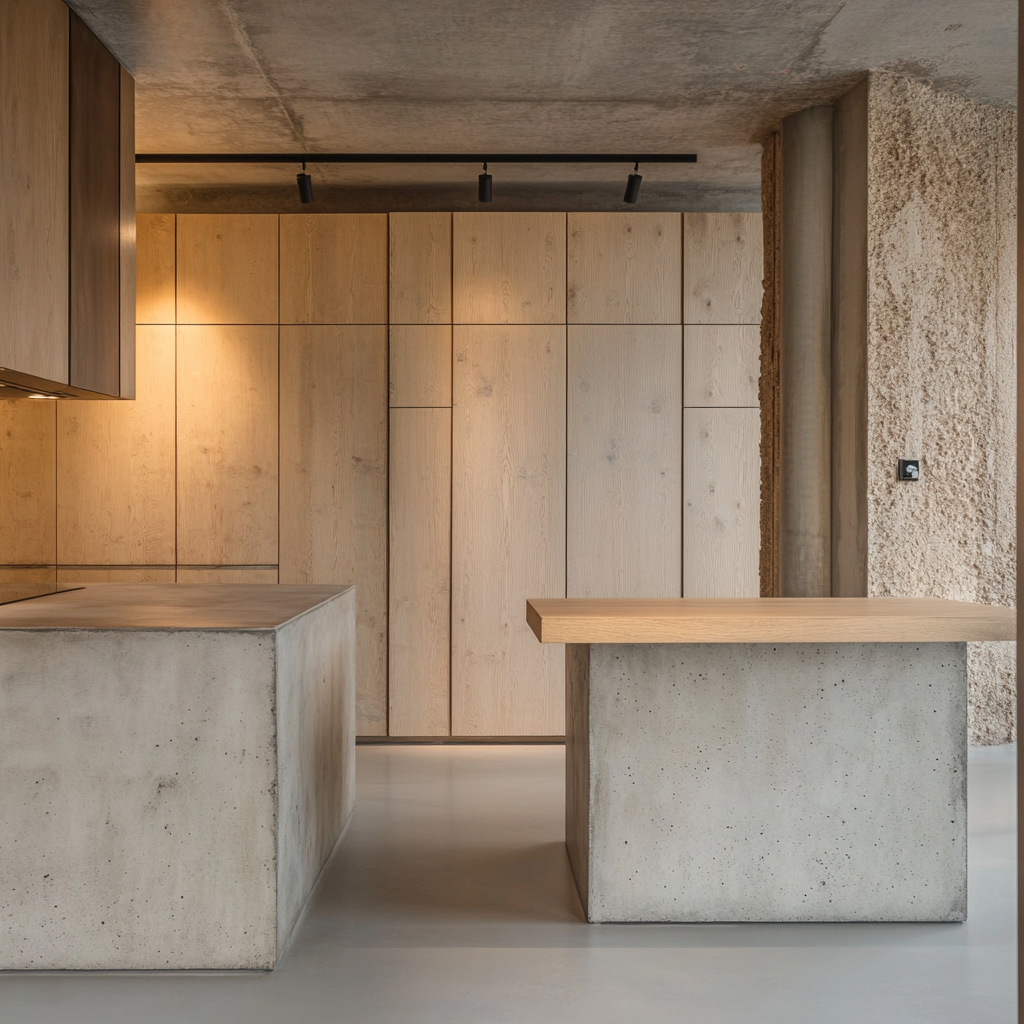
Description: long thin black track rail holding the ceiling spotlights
135,153,697,164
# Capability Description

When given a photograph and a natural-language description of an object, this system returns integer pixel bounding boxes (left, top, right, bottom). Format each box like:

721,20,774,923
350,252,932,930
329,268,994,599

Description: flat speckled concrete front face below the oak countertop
588,644,967,922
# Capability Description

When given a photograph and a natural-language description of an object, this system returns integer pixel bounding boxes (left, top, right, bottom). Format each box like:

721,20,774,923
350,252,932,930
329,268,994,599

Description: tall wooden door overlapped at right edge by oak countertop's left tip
452,327,565,736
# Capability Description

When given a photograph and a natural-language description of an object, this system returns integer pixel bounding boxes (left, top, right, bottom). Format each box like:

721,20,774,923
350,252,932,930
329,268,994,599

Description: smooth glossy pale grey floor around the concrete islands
0,746,1016,1024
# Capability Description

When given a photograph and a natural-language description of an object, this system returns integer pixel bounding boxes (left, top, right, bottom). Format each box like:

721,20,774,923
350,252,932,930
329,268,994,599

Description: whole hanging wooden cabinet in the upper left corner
0,0,135,398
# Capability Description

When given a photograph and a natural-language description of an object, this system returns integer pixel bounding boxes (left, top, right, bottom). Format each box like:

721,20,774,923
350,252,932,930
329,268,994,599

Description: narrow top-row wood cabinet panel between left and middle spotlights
390,213,452,324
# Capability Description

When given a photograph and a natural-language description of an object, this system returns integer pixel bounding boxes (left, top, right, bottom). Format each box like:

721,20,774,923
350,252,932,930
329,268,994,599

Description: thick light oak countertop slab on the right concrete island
526,597,1017,643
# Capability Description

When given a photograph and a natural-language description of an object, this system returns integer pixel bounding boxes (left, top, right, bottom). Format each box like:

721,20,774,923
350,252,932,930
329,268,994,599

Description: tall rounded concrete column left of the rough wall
779,106,833,597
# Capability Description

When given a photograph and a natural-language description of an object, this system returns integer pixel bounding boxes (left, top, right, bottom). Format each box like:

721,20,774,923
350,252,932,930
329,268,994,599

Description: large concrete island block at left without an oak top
0,584,355,970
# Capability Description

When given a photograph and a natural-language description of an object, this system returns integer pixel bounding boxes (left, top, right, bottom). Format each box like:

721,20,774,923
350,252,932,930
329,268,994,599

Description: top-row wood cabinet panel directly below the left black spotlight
281,213,387,324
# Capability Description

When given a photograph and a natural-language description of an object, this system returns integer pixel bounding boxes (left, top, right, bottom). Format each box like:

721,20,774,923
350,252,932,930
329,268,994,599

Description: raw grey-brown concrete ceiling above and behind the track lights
72,0,1017,209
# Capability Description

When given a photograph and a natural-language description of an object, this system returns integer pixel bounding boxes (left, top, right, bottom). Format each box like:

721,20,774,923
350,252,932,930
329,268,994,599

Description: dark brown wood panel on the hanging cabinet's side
69,11,121,396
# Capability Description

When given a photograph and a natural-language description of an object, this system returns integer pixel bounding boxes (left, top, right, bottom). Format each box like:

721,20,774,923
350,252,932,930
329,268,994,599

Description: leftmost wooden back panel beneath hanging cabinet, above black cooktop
0,398,58,565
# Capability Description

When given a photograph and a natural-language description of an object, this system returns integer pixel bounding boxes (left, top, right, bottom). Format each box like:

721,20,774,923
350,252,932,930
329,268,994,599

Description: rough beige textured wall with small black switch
867,74,1017,744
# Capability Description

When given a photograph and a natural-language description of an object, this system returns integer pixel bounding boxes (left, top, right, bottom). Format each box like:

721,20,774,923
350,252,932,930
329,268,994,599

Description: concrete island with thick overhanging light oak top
527,598,1015,922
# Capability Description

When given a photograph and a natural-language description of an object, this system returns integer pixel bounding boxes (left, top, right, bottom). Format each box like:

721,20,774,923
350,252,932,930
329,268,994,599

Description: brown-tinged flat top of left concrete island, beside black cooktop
0,583,351,635
